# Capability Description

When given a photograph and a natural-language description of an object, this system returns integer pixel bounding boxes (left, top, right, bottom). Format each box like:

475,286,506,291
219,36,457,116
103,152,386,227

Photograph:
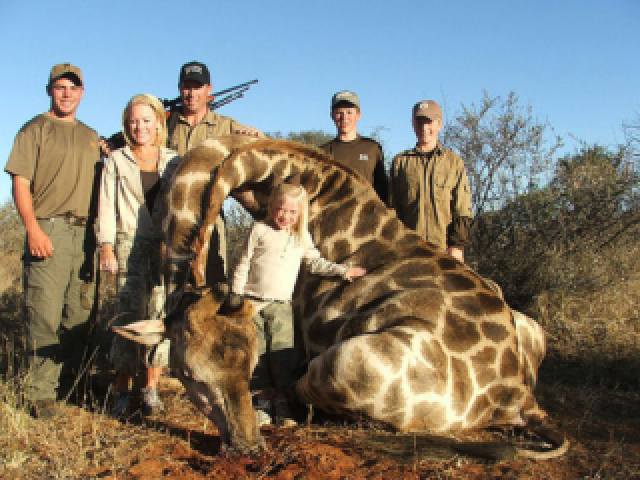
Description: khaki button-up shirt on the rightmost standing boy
390,144,473,250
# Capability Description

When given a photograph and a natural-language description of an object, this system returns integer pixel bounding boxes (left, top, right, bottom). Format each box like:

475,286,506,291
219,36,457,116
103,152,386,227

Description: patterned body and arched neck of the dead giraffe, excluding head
167,137,568,456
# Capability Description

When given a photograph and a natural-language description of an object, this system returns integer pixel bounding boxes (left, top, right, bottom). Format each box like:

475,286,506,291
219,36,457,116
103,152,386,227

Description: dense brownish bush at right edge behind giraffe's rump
469,147,640,389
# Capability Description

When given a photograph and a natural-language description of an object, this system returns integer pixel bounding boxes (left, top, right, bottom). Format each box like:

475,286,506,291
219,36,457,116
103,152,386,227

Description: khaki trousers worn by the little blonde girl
251,302,293,392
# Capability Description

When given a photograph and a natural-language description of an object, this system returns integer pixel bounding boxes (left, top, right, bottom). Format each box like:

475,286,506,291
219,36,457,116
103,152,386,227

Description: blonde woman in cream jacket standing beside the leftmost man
96,94,180,416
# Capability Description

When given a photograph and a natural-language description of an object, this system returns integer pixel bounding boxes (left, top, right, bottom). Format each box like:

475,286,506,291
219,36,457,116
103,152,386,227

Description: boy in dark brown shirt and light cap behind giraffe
320,90,388,203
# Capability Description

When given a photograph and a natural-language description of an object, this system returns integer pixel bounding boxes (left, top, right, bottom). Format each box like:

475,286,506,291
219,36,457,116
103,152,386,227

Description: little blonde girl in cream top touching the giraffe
232,183,366,425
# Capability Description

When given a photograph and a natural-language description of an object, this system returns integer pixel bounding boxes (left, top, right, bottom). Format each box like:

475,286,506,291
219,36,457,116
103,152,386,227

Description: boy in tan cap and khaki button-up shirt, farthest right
389,100,473,262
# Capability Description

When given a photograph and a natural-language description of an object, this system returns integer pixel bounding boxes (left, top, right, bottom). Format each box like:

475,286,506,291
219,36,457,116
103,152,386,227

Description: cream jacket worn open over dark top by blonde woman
96,145,180,244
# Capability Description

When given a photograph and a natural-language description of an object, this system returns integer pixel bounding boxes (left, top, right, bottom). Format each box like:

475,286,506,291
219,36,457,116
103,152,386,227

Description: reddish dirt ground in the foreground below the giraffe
69,379,640,479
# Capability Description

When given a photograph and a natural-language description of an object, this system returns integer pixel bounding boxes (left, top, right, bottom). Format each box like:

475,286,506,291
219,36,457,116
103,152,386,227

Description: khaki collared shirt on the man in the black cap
167,110,243,157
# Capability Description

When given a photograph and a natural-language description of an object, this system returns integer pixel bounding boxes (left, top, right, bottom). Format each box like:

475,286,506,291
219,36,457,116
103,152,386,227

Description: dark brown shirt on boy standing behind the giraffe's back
320,135,389,203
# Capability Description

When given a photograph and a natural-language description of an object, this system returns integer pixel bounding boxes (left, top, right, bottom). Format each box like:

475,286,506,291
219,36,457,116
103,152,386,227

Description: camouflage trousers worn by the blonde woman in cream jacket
109,234,169,375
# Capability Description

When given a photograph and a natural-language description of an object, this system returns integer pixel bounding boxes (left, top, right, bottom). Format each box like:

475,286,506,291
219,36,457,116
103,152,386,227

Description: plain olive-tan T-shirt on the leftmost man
5,113,101,218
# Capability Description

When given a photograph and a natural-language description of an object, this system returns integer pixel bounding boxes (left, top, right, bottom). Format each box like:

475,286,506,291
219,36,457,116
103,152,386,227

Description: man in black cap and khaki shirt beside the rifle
167,61,264,284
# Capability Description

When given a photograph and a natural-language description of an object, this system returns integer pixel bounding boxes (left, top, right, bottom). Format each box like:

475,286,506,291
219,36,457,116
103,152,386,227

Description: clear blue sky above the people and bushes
0,0,640,202
